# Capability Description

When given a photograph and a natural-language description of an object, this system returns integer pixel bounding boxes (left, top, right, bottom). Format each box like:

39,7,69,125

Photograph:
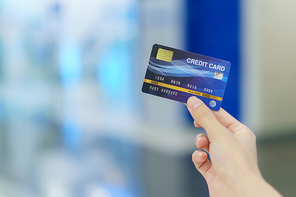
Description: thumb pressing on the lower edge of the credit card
187,96,230,141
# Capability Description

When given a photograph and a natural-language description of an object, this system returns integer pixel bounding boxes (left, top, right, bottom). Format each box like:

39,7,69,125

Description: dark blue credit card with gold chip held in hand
142,44,231,111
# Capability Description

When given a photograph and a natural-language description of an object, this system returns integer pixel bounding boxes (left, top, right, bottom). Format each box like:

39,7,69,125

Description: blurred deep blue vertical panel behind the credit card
186,0,240,119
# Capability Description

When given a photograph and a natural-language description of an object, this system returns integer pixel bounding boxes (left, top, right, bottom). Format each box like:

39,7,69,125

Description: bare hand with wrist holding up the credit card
187,97,281,197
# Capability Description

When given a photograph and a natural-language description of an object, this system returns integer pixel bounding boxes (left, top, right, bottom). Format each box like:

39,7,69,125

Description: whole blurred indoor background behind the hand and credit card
0,0,296,197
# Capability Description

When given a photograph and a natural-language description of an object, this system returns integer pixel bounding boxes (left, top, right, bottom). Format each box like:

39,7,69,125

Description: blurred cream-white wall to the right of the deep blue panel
242,0,296,137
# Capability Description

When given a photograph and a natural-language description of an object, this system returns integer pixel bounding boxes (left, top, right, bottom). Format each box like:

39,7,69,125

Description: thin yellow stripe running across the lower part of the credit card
144,79,222,101
